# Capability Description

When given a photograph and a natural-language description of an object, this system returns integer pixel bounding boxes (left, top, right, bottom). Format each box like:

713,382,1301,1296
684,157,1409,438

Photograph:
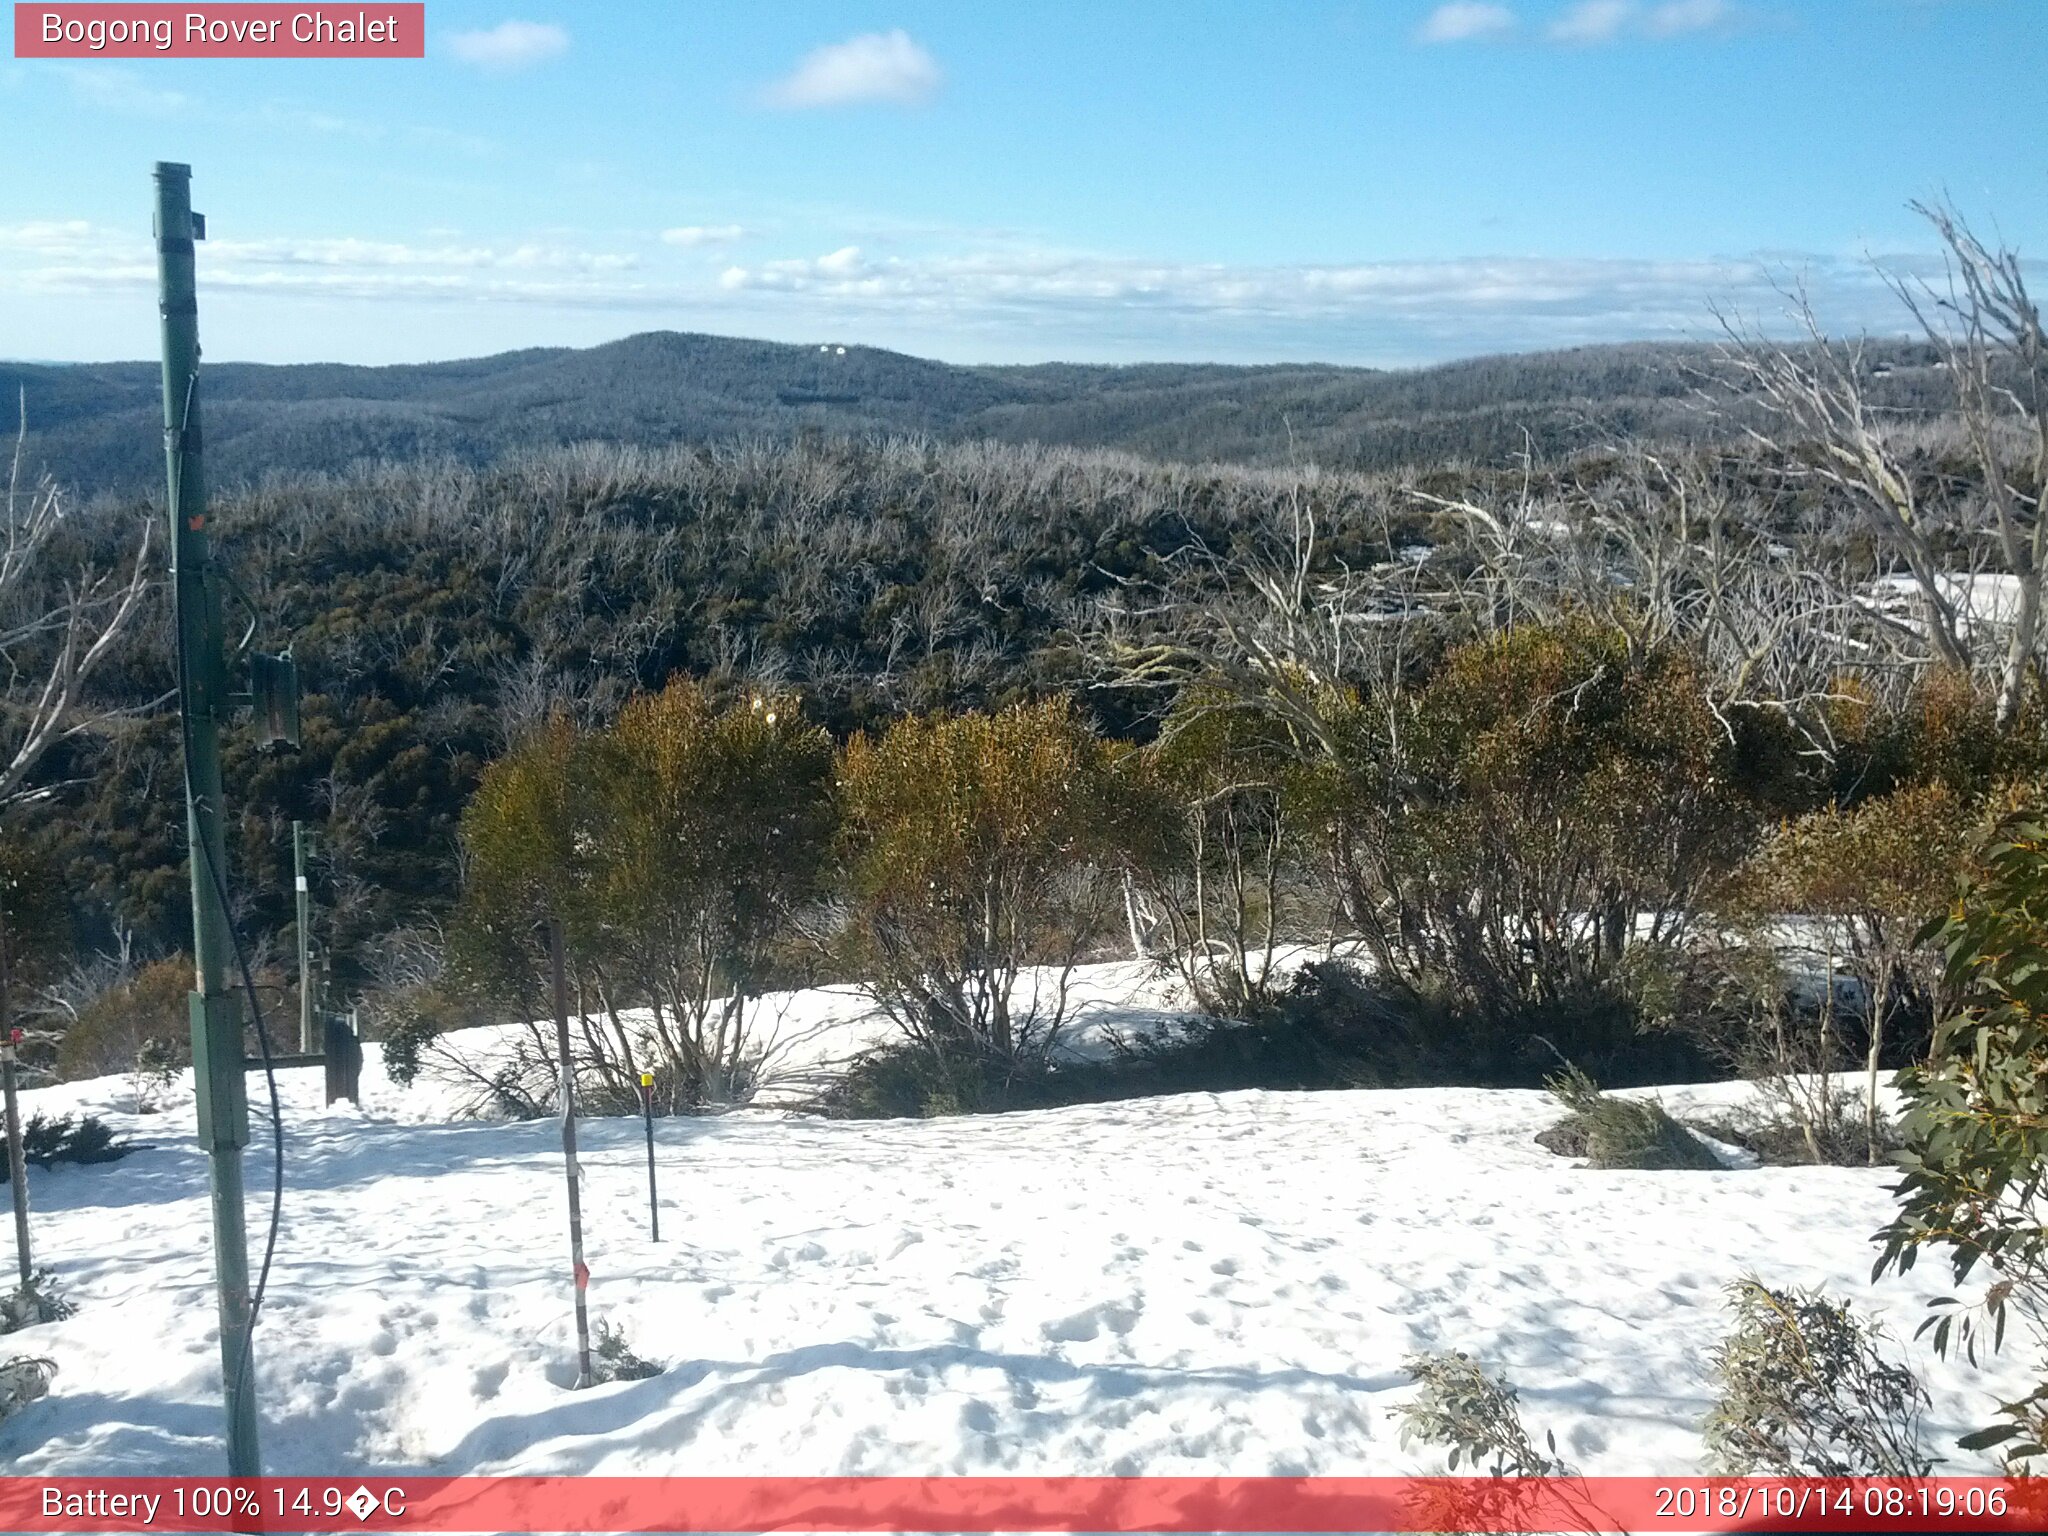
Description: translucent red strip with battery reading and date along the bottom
0,1477,2048,1534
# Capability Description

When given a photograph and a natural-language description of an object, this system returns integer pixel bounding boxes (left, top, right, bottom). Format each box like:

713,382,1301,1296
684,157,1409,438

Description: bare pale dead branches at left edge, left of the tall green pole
0,395,154,807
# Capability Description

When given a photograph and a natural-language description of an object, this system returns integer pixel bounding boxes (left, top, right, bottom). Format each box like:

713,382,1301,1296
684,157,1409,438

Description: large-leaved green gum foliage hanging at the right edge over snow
1876,811,2048,1464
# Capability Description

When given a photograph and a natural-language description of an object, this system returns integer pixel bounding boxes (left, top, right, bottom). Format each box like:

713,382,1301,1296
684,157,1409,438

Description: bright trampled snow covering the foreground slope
0,971,2021,1475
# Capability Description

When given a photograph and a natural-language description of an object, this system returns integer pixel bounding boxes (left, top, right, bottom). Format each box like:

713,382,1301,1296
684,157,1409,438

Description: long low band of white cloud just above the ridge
0,219,1982,365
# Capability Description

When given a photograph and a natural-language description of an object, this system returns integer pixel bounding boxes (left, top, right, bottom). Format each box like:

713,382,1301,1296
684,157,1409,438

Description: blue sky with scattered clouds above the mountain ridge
0,0,2048,365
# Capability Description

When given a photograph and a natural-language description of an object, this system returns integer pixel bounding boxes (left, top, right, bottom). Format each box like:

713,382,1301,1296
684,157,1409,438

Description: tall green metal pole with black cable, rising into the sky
156,162,262,1477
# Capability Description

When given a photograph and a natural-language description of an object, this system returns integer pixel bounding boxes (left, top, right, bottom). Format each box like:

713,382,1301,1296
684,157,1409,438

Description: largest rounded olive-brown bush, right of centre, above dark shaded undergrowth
1329,621,1759,1063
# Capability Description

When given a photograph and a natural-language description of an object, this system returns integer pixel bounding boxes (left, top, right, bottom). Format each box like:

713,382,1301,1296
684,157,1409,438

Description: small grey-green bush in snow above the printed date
1704,1280,1933,1477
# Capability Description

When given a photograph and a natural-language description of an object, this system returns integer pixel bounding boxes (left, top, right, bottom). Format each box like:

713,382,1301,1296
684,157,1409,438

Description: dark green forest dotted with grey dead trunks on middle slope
25,440,1430,978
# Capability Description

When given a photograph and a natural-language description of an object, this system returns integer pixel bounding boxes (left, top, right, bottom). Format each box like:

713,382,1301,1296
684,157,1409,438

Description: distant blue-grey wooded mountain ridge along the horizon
0,332,1931,494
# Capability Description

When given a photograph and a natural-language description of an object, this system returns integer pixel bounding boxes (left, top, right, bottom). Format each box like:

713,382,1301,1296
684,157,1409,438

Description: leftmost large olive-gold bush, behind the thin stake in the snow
460,682,831,1110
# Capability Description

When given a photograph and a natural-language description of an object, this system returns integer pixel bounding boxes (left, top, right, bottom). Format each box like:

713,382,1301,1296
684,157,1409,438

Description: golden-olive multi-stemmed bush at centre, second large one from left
840,700,1124,1063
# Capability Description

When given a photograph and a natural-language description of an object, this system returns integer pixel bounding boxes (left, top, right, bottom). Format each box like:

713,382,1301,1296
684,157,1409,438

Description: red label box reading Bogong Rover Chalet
14,0,426,59
